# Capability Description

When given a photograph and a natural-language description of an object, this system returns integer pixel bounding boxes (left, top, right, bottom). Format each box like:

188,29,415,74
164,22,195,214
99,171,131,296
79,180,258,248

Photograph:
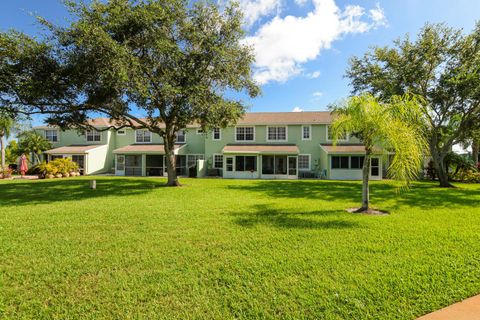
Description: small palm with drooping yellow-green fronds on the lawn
331,94,428,212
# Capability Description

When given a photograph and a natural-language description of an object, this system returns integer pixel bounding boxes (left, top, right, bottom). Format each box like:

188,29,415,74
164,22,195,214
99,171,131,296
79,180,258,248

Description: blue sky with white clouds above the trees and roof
0,0,480,122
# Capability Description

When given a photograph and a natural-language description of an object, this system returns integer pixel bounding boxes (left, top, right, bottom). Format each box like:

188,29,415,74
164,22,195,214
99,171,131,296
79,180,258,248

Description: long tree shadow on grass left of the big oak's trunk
0,177,165,207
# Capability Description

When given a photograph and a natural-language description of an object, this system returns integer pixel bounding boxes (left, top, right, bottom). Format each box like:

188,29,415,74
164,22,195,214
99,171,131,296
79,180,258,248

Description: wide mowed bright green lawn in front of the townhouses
0,177,480,319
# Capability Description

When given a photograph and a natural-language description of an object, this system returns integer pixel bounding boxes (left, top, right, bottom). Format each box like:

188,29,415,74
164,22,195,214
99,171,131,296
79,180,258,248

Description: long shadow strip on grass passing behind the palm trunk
229,180,480,210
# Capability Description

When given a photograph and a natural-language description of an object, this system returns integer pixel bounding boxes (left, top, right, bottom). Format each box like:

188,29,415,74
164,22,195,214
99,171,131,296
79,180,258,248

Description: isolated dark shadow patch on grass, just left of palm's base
232,205,359,229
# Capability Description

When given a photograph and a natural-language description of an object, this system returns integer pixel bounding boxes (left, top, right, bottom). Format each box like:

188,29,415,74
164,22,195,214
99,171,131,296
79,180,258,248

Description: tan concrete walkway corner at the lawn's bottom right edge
417,295,480,320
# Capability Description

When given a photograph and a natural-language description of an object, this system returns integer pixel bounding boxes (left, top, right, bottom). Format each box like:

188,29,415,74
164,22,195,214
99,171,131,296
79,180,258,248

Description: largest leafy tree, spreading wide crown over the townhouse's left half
0,0,259,186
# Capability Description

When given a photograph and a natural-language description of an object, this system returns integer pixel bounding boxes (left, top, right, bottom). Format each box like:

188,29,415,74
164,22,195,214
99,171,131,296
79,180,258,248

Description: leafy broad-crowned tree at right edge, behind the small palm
347,24,480,187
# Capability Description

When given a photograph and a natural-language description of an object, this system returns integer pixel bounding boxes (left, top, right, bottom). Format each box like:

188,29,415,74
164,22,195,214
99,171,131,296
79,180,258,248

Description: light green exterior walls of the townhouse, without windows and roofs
36,124,378,178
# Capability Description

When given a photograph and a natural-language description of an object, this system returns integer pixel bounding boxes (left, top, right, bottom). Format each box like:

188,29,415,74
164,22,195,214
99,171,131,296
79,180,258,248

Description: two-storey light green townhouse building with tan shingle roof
34,112,387,180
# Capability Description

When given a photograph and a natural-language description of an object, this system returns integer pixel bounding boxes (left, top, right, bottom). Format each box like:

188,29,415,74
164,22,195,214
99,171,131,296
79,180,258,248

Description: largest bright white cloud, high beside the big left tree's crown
244,0,384,84
